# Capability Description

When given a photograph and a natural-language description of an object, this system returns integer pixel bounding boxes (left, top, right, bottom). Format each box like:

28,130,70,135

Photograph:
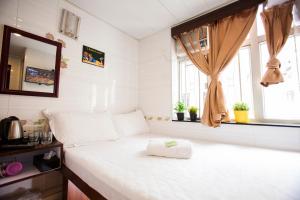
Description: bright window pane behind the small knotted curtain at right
260,36,300,120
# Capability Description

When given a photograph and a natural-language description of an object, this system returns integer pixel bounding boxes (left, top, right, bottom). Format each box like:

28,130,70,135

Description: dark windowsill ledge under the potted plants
172,119,300,128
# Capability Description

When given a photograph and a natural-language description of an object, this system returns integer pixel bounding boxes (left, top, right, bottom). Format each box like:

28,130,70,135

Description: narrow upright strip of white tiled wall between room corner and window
139,30,172,117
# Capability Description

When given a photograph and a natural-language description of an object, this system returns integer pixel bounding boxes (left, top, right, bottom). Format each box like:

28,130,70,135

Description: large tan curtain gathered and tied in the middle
177,7,257,127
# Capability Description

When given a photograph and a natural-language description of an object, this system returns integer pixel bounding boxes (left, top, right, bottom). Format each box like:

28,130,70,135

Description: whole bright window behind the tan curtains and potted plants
173,5,300,122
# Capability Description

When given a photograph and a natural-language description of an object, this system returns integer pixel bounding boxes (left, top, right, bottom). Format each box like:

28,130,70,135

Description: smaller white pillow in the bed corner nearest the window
114,110,149,136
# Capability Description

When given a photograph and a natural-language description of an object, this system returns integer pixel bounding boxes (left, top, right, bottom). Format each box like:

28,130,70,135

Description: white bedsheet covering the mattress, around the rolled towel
65,134,300,200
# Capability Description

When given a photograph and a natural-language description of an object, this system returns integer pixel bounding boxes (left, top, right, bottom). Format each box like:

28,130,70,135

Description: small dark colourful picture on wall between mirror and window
82,45,105,67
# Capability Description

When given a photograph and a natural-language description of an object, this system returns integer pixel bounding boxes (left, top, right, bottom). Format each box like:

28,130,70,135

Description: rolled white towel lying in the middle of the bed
146,138,192,158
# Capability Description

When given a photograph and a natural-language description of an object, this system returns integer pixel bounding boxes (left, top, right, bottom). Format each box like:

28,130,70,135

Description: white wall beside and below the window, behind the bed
139,29,300,151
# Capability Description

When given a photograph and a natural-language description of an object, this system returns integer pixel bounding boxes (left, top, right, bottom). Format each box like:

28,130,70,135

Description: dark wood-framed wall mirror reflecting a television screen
0,25,62,97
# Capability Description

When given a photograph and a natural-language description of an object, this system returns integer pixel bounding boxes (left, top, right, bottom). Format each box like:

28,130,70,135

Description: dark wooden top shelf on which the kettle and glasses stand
0,140,62,157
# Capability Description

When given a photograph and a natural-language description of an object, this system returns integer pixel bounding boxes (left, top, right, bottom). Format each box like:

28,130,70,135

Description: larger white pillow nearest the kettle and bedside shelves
43,111,118,147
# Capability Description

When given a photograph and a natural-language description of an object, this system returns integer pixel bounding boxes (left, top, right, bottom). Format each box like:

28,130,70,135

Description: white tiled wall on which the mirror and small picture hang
0,0,138,119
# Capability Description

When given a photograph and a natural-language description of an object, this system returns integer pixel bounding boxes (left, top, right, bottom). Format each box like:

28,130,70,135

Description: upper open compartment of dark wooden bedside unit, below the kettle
0,140,63,187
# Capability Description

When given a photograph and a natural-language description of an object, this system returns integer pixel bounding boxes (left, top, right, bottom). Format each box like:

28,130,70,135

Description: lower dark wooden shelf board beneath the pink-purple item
0,162,60,187
